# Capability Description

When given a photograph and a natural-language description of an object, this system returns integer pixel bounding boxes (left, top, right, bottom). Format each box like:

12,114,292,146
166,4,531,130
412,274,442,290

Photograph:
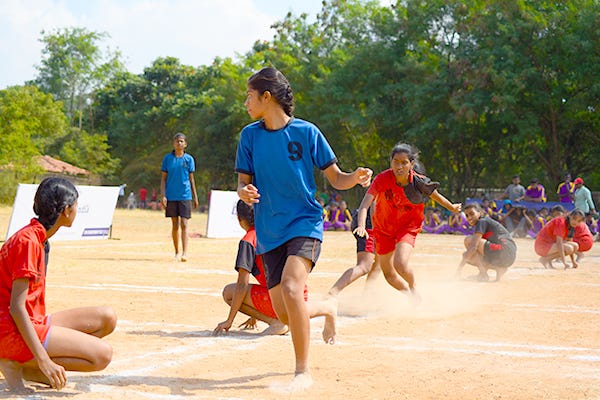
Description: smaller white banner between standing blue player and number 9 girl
206,190,246,238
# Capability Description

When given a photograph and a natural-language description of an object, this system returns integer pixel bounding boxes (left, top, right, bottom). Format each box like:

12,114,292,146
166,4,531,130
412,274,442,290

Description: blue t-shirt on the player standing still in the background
160,152,196,201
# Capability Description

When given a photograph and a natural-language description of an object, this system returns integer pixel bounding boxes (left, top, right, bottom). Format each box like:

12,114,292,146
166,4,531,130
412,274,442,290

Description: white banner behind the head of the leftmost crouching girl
6,183,119,241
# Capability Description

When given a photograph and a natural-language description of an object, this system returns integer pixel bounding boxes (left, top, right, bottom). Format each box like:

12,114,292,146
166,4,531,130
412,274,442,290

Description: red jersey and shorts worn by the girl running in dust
367,169,424,254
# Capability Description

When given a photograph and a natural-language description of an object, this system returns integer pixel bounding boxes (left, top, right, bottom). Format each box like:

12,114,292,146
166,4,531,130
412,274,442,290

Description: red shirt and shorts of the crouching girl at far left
0,218,50,363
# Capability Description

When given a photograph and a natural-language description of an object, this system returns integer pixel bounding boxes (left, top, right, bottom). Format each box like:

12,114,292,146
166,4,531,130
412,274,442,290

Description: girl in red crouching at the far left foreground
0,178,117,392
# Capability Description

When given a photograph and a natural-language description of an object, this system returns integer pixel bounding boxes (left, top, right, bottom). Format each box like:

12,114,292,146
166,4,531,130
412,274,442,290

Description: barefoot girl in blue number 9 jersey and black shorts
235,68,373,390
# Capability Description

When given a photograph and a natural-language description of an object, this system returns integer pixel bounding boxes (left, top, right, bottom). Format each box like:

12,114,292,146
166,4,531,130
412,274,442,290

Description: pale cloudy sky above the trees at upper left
0,0,322,90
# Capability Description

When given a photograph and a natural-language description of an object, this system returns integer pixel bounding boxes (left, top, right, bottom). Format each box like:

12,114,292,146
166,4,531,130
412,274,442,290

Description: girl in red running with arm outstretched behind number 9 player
354,143,461,302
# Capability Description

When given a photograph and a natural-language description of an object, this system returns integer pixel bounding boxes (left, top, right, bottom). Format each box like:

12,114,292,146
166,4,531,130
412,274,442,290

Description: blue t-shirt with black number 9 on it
235,118,337,254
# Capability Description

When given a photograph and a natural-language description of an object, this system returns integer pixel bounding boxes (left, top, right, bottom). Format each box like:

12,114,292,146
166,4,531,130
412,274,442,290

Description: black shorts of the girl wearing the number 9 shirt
261,237,321,289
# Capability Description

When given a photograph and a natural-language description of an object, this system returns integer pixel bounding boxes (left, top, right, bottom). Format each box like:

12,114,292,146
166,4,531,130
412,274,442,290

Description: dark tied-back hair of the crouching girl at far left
33,177,79,230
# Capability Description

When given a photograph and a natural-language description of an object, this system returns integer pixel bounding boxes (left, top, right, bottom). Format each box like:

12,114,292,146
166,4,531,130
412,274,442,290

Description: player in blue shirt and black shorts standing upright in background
160,132,198,261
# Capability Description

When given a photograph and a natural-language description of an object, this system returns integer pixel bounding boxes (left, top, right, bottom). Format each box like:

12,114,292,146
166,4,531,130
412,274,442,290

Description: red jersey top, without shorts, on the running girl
367,169,425,236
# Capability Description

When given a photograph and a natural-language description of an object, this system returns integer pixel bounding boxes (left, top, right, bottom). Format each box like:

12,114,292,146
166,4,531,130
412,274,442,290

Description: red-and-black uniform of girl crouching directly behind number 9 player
235,227,308,318
